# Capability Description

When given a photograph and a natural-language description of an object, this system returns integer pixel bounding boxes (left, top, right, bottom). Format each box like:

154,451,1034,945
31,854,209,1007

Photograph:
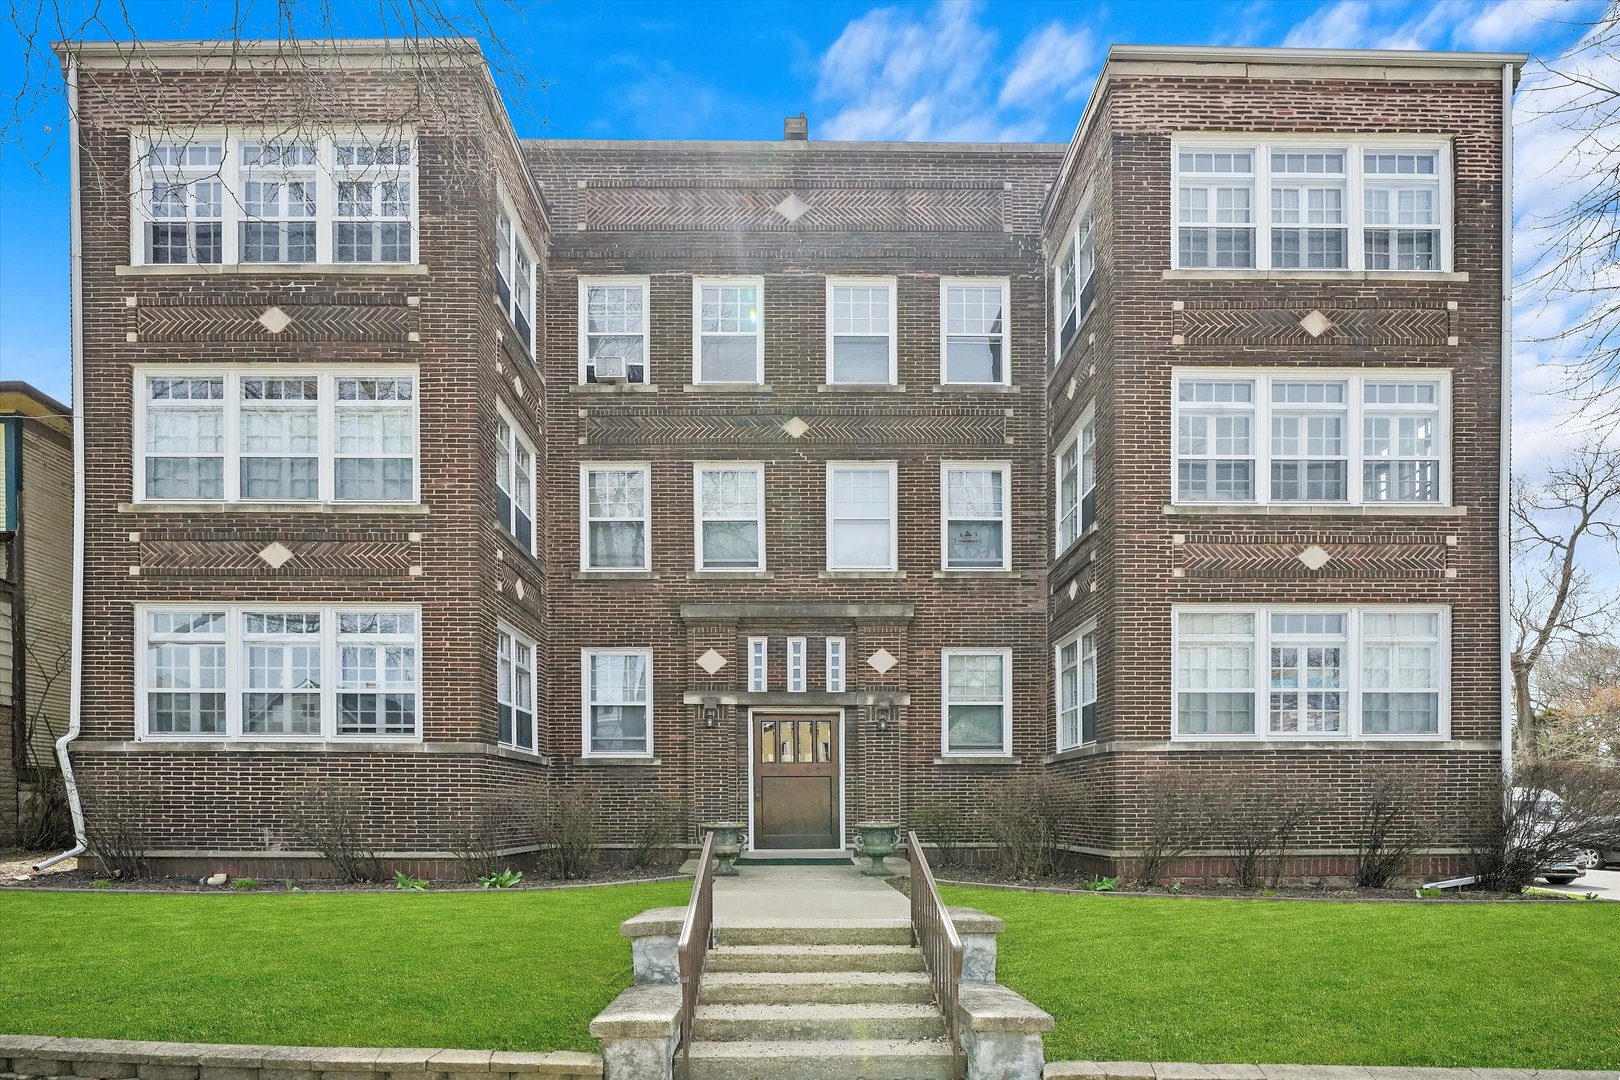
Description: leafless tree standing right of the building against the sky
1510,444,1620,753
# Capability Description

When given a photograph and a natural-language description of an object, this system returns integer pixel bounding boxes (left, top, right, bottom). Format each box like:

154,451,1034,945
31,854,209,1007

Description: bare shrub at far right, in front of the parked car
1471,758,1620,892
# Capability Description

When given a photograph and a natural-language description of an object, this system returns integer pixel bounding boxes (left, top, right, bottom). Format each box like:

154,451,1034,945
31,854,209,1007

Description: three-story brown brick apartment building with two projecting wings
53,42,1523,876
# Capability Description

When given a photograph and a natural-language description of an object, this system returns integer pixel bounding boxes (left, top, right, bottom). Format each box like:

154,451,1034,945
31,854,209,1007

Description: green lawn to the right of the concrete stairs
941,887,1620,1069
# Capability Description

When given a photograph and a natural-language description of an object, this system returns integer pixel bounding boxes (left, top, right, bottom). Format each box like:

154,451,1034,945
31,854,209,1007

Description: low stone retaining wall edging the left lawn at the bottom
0,1035,603,1080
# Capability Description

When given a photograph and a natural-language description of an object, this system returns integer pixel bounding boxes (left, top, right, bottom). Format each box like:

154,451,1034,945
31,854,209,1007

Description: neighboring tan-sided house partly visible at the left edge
0,382,73,848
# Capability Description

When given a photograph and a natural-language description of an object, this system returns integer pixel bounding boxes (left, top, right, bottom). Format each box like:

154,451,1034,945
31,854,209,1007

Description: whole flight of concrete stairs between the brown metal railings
676,920,954,1080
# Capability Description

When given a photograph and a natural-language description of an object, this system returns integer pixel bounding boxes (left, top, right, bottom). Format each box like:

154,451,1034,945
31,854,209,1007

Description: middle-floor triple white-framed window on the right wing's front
1171,368,1450,505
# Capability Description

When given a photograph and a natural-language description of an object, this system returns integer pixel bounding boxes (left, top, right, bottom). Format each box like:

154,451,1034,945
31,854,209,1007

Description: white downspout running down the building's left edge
34,57,89,871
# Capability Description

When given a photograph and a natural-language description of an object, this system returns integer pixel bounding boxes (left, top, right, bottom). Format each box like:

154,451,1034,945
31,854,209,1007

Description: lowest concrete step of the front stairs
676,1040,956,1080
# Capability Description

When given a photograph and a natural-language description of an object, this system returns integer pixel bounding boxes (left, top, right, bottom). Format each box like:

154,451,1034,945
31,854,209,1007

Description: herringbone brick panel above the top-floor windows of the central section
583,185,1003,233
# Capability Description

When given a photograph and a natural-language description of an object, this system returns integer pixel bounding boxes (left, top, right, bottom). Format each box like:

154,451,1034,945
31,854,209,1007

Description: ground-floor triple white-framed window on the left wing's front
136,604,421,742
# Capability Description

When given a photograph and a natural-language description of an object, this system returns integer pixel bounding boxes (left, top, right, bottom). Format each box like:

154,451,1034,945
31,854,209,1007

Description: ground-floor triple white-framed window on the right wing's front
1173,604,1450,740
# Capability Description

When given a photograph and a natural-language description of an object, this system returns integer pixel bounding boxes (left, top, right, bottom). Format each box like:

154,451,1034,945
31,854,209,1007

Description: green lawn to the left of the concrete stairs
0,881,692,1051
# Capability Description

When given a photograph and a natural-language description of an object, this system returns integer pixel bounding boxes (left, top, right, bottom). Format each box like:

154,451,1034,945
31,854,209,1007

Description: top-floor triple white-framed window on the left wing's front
130,128,418,266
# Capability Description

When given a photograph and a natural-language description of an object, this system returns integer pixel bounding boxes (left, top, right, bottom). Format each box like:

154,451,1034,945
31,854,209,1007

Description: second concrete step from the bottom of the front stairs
692,1004,946,1049
